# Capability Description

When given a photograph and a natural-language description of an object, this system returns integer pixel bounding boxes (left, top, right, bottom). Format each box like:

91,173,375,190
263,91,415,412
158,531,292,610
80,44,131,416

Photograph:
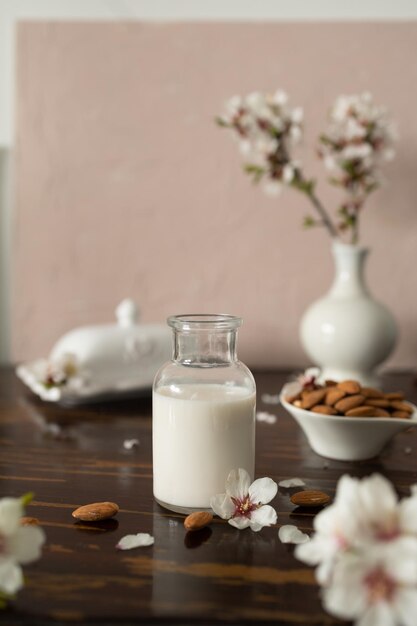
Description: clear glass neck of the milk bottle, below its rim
172,329,237,367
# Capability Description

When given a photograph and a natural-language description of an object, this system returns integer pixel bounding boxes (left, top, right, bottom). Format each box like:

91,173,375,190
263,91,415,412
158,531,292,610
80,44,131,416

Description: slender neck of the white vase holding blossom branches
330,242,369,297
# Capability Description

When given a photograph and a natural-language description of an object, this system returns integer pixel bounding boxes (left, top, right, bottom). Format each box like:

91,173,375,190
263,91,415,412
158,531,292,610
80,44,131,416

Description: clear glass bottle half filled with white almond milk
152,314,256,513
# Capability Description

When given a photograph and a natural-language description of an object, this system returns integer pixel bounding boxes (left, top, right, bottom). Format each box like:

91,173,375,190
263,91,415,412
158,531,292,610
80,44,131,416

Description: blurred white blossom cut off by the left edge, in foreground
0,498,45,595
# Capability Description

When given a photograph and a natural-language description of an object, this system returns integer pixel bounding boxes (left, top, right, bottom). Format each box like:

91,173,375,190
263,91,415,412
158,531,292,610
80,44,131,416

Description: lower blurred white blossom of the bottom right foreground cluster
323,538,417,626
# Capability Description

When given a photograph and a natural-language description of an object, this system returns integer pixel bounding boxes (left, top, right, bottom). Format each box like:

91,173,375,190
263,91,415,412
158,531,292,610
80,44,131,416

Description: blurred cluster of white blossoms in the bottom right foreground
295,474,417,626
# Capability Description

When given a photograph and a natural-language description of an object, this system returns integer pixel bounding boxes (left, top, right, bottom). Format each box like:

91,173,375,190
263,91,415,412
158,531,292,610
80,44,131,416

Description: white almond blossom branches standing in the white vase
217,90,395,244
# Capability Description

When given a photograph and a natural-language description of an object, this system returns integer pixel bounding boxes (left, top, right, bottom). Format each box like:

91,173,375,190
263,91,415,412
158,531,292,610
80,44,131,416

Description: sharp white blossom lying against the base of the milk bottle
210,468,278,532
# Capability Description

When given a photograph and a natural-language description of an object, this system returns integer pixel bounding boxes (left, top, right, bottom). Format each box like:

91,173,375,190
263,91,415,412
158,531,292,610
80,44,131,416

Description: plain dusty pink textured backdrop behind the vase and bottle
12,22,417,366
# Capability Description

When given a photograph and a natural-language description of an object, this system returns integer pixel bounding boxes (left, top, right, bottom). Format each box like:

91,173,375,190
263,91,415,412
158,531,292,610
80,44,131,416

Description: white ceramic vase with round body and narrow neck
300,242,397,385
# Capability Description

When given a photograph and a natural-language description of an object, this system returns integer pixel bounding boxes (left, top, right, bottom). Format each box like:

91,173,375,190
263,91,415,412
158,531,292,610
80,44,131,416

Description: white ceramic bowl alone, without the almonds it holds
280,383,417,461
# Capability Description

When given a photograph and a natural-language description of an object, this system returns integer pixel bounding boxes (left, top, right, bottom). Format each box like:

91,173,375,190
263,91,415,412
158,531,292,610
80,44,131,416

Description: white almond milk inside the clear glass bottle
153,384,255,508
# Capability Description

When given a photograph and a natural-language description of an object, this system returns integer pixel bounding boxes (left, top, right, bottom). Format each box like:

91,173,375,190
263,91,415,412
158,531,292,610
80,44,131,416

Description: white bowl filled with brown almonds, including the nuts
280,380,417,461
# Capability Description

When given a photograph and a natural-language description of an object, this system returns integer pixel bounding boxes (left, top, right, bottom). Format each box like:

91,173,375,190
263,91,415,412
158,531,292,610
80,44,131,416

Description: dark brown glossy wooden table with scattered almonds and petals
0,369,417,626
